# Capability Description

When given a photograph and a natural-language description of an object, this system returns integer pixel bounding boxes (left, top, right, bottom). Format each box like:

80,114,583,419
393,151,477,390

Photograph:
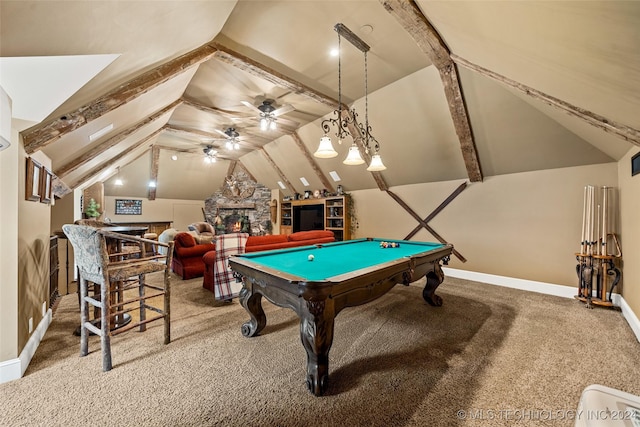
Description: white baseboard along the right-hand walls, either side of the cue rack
442,267,640,341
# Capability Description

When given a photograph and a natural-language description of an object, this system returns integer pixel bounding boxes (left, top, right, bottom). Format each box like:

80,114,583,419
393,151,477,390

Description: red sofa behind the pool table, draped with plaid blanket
202,230,336,292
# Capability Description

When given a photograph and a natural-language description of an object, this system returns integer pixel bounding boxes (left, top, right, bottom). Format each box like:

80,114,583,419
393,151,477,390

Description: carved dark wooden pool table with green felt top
229,238,453,396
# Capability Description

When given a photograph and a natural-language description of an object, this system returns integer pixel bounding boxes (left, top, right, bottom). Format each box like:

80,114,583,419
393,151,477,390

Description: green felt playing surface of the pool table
232,239,445,281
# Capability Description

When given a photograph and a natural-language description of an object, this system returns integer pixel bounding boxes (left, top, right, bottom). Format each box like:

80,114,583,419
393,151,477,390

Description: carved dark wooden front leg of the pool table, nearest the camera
300,300,335,396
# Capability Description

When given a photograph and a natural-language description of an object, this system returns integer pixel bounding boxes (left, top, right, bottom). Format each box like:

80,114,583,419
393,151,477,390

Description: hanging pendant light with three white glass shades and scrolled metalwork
313,23,386,171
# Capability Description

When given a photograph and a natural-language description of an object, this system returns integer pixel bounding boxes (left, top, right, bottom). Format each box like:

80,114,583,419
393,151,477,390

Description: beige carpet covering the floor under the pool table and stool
0,277,640,426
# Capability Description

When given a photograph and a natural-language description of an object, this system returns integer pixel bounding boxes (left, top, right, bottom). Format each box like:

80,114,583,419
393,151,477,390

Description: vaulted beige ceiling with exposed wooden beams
0,0,640,200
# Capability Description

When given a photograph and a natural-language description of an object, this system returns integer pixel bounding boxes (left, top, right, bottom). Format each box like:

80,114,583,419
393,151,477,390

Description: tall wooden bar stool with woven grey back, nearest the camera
62,224,173,371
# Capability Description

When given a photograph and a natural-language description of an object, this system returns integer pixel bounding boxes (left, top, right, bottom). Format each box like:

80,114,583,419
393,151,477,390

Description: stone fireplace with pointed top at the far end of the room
204,172,275,236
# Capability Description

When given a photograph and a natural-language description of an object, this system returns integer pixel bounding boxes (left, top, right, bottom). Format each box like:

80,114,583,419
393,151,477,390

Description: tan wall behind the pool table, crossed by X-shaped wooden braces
352,163,618,286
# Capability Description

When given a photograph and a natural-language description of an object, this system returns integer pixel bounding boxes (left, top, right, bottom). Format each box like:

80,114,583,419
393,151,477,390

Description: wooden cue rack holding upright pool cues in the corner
575,185,622,308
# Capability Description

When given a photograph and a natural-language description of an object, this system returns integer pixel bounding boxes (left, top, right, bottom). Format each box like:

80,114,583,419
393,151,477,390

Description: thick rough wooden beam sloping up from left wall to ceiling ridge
21,44,215,154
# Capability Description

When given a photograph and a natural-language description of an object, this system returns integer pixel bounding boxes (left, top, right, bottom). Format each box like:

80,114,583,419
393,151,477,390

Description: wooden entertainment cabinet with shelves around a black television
280,196,351,241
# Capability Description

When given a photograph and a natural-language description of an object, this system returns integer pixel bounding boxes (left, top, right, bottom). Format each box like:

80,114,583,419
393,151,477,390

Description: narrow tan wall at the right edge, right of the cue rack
618,147,640,318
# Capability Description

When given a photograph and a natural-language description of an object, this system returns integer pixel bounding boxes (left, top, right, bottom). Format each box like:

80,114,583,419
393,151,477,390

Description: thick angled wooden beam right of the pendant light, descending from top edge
380,0,483,182
